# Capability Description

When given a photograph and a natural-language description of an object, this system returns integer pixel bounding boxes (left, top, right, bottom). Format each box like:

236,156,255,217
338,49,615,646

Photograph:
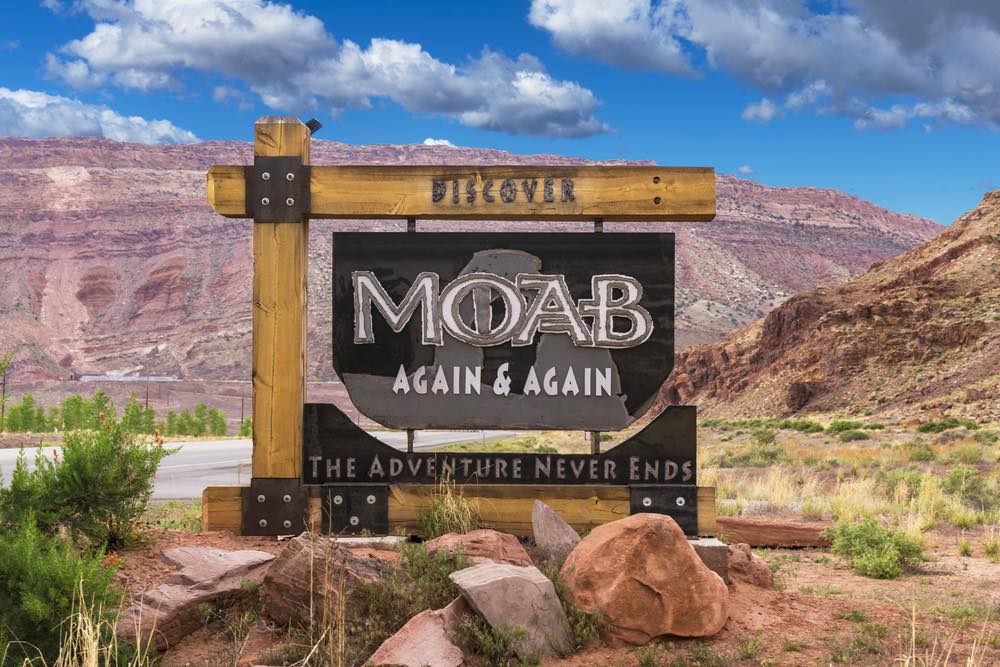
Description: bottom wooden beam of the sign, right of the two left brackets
389,484,715,536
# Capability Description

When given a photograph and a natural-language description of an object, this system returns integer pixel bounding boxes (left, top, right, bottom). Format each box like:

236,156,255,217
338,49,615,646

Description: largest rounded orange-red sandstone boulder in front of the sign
559,514,729,645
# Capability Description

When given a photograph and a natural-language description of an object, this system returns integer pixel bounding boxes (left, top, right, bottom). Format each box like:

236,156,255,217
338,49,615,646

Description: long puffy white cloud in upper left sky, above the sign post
48,0,610,137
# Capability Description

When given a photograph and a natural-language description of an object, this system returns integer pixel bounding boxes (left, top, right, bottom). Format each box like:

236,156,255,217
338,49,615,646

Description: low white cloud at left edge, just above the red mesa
0,88,198,144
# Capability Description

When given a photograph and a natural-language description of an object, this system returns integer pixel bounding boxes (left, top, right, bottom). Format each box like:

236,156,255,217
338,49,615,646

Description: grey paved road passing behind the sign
0,431,515,500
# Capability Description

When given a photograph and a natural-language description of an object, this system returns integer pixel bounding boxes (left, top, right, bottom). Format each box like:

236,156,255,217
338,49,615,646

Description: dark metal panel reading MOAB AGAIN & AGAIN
333,233,674,430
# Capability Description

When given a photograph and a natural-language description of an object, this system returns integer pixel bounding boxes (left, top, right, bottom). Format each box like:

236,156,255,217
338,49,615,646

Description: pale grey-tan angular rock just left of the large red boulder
449,563,570,661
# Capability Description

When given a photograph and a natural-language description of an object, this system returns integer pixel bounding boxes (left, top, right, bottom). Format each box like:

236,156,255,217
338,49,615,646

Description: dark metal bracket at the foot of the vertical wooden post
242,477,307,535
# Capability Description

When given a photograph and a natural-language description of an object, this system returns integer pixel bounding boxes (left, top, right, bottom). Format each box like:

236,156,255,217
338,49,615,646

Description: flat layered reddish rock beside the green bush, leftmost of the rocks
115,547,274,651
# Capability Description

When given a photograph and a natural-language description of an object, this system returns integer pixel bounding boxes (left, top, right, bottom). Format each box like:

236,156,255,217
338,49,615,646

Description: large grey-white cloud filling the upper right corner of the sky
529,0,1000,129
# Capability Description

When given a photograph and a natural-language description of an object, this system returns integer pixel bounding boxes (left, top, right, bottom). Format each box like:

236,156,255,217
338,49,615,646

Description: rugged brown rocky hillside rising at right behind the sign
662,190,1000,421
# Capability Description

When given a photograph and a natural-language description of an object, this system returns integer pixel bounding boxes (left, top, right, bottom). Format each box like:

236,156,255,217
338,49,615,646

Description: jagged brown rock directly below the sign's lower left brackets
261,533,388,625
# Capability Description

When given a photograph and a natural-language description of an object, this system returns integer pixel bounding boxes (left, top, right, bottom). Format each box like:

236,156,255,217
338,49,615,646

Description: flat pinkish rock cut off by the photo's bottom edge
365,605,464,667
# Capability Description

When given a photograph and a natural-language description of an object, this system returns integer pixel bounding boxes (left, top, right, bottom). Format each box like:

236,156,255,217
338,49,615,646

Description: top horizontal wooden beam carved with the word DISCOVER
209,165,716,221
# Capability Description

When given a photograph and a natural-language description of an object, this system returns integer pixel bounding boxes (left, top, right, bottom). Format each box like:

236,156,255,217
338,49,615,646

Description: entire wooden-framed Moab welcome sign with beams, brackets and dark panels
202,117,715,535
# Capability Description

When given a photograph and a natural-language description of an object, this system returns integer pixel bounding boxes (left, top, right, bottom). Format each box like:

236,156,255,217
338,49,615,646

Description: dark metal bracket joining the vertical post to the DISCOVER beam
243,156,311,222
